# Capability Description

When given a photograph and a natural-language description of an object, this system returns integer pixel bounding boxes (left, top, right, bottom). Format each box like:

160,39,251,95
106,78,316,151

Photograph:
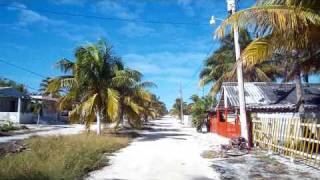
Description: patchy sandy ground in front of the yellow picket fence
202,151,319,180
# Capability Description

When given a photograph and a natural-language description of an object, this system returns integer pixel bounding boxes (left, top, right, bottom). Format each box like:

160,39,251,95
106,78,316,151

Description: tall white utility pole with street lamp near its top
210,0,249,140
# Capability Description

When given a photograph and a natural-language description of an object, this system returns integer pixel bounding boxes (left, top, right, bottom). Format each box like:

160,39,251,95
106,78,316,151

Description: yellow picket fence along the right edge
252,114,320,168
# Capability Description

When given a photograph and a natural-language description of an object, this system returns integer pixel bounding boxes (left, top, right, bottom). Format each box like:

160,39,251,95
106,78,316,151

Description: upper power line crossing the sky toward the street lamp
0,4,208,26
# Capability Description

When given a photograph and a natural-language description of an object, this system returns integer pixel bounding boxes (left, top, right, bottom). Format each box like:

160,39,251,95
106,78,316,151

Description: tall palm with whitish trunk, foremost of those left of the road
48,41,123,134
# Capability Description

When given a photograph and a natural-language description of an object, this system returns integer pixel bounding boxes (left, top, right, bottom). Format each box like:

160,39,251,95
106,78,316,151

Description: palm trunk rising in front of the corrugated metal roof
294,63,305,113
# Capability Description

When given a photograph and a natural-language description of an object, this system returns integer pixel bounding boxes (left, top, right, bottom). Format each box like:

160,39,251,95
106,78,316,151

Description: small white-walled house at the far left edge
0,87,33,124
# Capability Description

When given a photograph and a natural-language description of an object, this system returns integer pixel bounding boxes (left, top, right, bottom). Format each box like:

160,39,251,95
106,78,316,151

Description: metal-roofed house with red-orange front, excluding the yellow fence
210,82,320,138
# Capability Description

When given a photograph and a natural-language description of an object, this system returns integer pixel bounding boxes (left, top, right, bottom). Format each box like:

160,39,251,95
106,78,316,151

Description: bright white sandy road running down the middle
88,117,227,180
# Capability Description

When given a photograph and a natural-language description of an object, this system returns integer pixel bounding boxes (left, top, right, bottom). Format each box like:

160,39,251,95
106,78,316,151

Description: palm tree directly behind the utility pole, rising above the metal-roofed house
200,30,281,97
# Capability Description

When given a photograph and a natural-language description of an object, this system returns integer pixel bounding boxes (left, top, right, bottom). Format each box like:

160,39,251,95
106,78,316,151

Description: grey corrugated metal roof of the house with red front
218,82,320,110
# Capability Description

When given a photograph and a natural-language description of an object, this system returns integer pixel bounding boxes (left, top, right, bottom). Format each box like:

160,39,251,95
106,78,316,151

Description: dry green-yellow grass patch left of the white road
0,134,130,180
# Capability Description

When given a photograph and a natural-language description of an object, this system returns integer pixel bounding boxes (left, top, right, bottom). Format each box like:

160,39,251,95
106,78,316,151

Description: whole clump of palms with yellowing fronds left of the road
47,40,166,134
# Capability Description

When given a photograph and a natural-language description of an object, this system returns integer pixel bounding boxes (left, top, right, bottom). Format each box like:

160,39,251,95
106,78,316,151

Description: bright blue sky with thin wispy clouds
0,0,253,107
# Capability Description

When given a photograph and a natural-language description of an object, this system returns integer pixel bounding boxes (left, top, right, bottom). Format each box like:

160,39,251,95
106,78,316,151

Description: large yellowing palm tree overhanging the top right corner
216,0,320,112
